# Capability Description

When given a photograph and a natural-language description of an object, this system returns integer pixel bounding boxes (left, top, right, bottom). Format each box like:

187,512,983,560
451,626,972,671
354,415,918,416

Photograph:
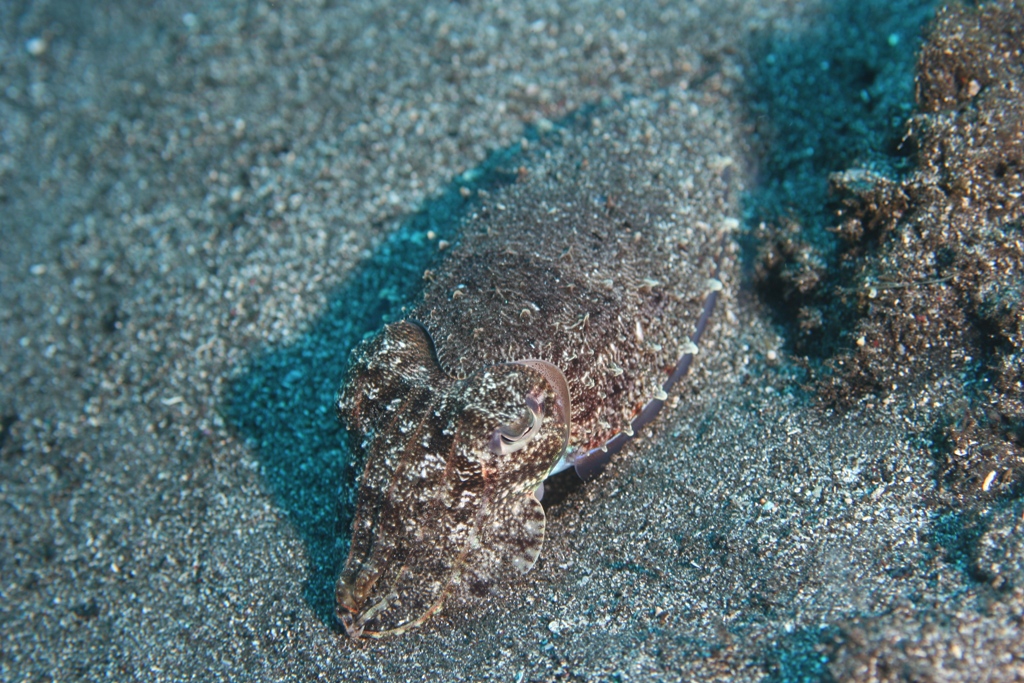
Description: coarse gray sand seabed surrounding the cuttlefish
0,0,1024,681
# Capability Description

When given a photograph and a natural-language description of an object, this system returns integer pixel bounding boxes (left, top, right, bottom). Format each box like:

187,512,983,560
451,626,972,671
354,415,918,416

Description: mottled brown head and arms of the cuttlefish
337,321,571,638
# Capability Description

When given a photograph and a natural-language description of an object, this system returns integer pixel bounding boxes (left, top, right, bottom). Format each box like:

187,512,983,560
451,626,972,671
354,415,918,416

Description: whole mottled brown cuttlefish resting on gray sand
337,97,731,638
